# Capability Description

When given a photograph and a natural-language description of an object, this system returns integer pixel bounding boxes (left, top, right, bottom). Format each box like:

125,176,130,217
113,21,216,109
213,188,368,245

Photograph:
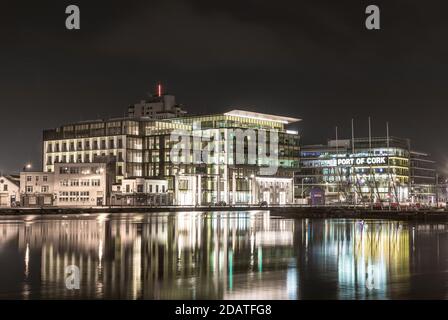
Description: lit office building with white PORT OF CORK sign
295,137,434,204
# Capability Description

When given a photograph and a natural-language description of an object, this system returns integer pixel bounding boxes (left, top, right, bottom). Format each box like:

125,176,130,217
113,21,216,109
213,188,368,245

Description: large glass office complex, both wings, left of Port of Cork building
43,110,300,205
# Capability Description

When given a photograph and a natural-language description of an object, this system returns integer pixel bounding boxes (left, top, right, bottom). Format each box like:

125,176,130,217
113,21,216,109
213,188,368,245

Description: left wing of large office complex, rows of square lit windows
43,118,190,184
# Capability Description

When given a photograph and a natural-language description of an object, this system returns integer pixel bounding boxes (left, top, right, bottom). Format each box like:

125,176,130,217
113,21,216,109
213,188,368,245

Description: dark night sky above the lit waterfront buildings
0,0,448,173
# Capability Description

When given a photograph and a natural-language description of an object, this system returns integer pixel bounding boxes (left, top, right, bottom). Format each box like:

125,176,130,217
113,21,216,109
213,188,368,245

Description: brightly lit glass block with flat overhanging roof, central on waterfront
173,110,300,205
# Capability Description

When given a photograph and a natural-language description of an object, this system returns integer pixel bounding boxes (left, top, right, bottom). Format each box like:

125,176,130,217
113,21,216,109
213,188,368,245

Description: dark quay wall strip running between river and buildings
0,206,448,221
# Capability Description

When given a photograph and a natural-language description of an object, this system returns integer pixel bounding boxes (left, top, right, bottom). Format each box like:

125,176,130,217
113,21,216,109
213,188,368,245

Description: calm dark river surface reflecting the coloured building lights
0,211,448,299
